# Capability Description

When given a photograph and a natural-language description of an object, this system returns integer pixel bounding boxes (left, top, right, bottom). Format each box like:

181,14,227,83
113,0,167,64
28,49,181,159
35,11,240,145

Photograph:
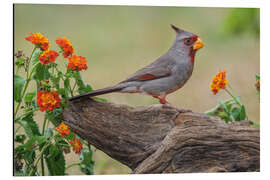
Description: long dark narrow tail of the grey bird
69,86,123,101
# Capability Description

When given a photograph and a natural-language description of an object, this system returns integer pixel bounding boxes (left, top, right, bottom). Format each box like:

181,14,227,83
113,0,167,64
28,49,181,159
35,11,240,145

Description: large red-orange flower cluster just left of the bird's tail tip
37,91,60,112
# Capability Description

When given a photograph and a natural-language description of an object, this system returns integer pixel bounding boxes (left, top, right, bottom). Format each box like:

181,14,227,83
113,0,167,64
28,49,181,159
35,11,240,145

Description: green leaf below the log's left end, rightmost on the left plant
80,148,95,175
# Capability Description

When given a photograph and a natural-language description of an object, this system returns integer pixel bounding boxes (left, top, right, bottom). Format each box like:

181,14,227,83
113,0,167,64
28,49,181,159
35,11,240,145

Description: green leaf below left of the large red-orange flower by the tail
19,113,40,138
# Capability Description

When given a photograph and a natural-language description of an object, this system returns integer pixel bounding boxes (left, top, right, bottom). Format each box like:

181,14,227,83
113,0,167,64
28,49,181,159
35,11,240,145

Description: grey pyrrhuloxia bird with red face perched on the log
70,25,203,111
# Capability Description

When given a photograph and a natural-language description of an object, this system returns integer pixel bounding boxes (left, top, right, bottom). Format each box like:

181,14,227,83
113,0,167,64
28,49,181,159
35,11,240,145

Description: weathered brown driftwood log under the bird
63,98,260,173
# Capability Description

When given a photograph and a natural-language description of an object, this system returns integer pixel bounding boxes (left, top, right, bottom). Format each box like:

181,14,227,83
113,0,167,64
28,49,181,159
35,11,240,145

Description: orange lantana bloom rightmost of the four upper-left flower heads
67,55,87,71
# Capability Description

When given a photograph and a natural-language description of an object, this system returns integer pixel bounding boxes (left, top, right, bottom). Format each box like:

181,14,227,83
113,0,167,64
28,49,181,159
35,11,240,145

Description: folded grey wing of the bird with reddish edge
121,54,172,83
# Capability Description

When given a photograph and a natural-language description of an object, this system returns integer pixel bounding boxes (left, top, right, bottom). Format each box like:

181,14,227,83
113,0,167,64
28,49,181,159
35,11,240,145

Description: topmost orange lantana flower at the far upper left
25,33,50,50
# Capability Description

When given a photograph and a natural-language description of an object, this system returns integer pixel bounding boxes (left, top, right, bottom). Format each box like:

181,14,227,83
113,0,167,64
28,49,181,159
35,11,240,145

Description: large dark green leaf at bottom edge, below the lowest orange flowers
45,144,65,176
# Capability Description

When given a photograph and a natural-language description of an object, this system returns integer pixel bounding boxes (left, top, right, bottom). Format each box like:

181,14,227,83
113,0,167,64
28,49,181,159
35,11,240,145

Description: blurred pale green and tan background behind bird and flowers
14,4,260,174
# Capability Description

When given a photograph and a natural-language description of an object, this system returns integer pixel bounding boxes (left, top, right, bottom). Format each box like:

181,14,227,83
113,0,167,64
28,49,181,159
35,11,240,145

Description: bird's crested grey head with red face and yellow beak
171,25,204,61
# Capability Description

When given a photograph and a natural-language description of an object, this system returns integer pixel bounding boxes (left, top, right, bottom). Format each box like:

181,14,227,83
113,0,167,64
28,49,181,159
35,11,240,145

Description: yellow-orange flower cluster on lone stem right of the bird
210,70,228,94
